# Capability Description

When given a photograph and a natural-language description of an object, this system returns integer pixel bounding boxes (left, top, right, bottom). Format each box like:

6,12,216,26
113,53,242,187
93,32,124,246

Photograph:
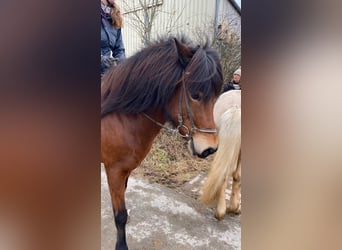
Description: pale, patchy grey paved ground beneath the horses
101,168,241,250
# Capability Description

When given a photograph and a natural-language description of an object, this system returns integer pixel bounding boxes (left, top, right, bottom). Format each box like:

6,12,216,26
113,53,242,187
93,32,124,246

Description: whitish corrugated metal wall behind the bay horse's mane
117,0,228,56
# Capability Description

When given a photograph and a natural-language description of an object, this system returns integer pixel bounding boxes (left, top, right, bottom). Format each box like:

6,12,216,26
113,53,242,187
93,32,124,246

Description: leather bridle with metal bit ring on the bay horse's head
143,72,217,141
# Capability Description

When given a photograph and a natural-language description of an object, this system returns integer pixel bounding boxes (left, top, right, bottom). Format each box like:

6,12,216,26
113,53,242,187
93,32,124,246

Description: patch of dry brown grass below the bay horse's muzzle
132,130,213,198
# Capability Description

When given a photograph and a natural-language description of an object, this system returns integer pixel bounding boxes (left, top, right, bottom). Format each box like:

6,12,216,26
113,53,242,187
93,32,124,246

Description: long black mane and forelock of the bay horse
101,37,223,117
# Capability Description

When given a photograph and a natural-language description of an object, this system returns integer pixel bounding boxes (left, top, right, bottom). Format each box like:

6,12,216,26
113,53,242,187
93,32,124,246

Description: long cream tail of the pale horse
200,107,241,206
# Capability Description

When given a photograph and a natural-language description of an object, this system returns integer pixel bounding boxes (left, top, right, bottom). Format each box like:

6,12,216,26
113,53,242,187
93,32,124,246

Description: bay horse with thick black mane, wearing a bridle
101,38,223,250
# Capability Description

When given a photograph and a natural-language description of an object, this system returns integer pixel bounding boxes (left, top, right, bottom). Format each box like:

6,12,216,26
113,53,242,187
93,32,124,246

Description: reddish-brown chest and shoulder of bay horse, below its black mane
101,113,165,166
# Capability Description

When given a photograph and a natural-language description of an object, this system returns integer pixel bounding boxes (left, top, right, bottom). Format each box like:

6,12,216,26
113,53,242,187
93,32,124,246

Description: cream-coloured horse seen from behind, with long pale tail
200,90,241,220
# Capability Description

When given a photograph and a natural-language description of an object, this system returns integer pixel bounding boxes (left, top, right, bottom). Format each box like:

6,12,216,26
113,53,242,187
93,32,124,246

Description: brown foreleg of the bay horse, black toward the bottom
106,168,129,250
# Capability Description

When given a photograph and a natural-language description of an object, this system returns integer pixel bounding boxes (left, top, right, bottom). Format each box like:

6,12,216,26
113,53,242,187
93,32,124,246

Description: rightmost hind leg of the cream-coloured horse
228,154,241,214
